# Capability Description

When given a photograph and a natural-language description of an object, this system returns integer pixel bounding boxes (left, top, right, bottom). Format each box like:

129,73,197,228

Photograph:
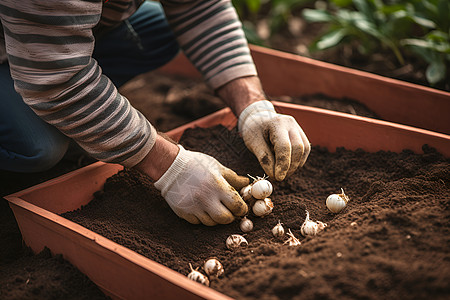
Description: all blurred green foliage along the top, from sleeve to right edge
233,0,450,88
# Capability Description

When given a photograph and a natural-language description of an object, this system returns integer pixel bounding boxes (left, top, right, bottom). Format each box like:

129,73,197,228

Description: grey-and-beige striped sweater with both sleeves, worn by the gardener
0,0,256,167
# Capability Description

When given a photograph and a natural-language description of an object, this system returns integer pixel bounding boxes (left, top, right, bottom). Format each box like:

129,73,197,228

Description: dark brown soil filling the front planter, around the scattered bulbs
64,126,450,299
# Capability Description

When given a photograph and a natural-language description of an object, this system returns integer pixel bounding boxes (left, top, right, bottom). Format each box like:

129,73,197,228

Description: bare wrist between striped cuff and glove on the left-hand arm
134,134,180,181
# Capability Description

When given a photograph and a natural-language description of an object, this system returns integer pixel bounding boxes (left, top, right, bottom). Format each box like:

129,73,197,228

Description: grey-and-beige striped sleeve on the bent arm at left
0,0,156,167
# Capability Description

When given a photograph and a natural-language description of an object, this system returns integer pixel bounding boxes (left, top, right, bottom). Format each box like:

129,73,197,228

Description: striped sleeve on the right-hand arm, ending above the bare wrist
161,0,257,89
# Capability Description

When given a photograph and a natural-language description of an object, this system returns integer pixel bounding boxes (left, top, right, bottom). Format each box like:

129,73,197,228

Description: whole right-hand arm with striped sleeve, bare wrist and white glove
161,0,310,180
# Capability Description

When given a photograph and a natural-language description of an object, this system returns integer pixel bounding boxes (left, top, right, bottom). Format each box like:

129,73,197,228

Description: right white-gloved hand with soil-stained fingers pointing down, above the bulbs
238,100,311,181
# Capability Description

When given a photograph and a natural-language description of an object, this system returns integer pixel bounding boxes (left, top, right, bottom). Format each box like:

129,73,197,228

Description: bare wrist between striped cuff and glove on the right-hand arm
216,76,267,116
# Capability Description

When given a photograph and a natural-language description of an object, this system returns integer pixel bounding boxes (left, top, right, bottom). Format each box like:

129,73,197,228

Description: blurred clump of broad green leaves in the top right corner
302,0,450,85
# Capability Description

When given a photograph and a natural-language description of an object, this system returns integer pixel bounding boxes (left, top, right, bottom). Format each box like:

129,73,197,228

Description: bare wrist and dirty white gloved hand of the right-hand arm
217,76,311,180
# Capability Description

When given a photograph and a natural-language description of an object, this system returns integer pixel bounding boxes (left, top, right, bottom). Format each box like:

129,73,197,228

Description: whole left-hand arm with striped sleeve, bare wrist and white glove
0,0,248,225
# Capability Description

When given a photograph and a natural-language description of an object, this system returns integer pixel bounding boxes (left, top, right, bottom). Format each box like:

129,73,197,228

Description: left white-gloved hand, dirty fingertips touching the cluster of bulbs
155,145,249,226
